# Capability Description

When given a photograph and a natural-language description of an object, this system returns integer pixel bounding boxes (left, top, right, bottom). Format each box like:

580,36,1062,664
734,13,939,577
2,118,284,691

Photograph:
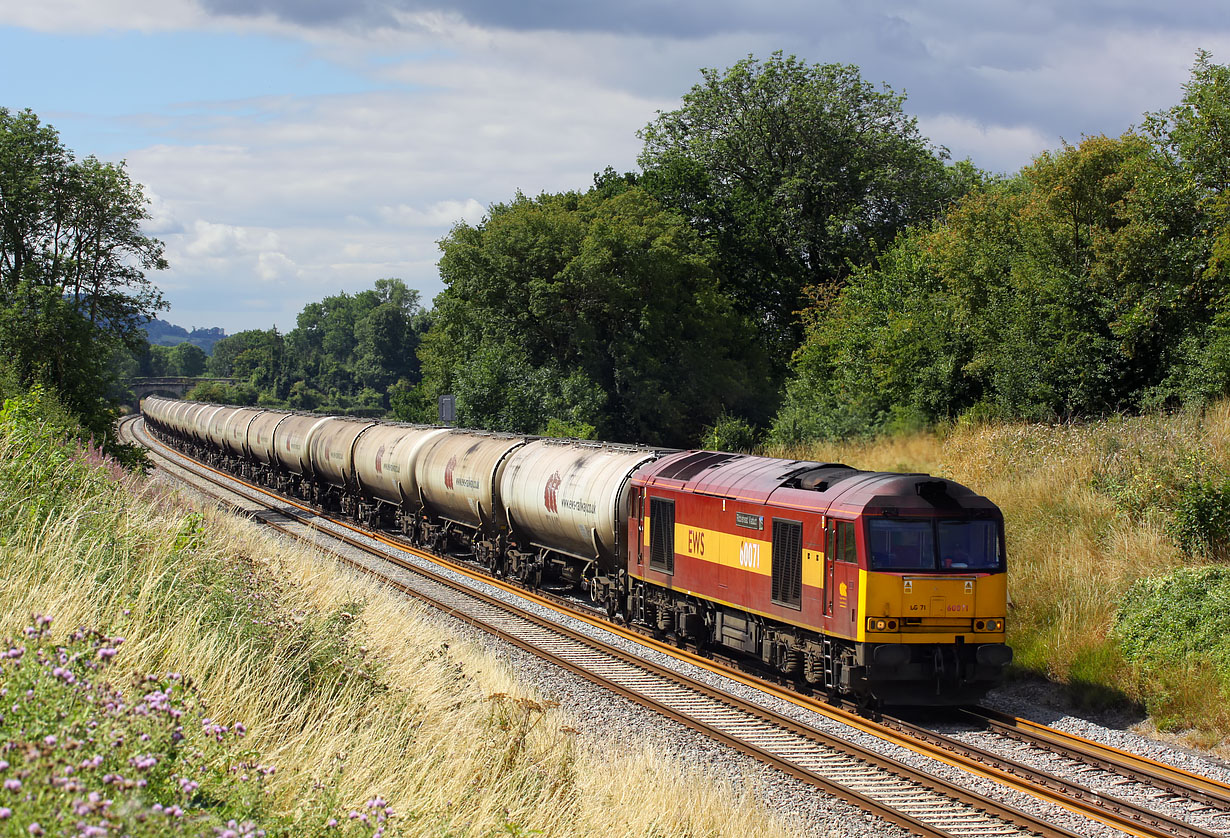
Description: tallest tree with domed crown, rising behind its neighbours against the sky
640,52,978,363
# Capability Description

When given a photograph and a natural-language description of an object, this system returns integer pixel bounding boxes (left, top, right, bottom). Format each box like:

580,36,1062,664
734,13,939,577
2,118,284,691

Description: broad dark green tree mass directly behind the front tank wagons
419,186,766,444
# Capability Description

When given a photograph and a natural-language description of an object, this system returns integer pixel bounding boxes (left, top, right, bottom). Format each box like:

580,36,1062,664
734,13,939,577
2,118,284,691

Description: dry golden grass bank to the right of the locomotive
766,401,1230,746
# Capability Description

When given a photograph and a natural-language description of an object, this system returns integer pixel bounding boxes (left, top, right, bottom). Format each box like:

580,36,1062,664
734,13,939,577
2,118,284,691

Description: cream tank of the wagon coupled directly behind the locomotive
499,439,654,573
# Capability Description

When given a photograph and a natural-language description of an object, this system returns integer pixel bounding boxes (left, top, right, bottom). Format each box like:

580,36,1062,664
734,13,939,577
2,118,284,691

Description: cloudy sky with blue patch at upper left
0,0,1230,333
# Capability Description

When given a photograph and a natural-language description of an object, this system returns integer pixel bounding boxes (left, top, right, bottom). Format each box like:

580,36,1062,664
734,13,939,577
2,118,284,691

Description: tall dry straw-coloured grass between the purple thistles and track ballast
0,408,792,838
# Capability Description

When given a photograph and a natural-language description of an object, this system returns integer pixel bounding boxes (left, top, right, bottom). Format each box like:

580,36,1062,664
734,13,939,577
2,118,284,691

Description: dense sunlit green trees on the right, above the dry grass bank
775,55,1230,439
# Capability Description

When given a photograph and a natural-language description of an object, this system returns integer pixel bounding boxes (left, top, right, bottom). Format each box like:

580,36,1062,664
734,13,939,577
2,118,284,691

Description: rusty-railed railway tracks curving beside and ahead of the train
125,421,1230,837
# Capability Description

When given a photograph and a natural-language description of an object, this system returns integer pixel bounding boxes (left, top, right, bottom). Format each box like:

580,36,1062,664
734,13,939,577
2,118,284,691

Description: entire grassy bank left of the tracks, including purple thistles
0,393,788,837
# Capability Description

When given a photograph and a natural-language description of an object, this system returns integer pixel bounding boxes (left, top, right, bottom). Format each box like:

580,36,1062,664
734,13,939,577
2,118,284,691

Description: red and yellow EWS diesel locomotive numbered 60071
627,452,1012,704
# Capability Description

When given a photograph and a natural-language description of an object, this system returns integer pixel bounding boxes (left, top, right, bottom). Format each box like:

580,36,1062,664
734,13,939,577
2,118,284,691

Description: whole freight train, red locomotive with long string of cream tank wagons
141,396,1012,706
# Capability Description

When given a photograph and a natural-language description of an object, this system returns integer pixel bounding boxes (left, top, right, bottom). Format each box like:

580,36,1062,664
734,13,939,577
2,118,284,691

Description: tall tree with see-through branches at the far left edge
0,108,166,448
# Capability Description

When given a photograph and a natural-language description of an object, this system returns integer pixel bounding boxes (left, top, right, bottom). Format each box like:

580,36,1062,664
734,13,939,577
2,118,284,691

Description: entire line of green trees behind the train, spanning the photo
9,53,1230,448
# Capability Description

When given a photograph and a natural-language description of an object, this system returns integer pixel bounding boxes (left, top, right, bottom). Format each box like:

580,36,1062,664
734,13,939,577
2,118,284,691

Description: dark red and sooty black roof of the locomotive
637,452,996,514
